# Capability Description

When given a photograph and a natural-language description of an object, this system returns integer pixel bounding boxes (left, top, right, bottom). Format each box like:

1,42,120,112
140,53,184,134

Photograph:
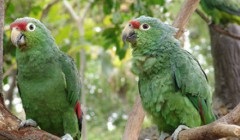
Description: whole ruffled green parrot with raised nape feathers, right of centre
122,16,215,139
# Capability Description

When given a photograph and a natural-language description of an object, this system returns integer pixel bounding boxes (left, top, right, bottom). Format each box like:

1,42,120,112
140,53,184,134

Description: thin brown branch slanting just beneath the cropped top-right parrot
196,9,240,40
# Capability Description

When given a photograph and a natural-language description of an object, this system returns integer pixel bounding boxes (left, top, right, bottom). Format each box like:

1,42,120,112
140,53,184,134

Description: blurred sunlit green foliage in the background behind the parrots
1,0,214,140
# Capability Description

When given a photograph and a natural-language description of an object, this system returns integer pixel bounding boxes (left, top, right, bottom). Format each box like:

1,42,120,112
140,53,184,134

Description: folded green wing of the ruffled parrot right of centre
171,49,215,124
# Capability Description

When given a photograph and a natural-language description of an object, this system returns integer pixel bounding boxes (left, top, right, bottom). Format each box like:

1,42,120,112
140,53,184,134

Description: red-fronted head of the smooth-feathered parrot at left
10,17,54,50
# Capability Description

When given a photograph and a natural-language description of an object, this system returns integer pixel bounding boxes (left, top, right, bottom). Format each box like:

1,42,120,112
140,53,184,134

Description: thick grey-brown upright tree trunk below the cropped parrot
209,24,240,116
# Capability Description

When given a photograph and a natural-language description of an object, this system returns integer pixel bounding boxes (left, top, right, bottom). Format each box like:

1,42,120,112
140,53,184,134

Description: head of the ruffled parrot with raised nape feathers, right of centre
122,16,177,49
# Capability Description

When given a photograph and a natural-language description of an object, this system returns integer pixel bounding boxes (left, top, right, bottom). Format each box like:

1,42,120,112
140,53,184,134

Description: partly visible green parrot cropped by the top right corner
200,0,240,25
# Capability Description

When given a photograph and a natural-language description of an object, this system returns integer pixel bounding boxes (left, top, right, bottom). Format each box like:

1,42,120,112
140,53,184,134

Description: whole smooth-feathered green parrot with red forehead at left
10,17,82,140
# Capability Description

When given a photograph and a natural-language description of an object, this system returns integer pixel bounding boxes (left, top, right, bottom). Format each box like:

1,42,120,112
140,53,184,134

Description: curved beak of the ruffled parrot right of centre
122,24,137,44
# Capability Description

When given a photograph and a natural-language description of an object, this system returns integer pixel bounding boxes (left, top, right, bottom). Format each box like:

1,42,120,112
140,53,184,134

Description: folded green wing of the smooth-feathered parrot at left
59,53,81,106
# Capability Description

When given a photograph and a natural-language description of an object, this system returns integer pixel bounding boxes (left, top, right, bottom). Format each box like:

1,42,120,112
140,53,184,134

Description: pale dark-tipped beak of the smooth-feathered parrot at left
11,28,26,48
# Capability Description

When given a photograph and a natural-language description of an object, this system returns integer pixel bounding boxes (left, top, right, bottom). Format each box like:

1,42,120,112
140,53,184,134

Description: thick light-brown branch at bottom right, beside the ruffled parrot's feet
167,104,240,140
